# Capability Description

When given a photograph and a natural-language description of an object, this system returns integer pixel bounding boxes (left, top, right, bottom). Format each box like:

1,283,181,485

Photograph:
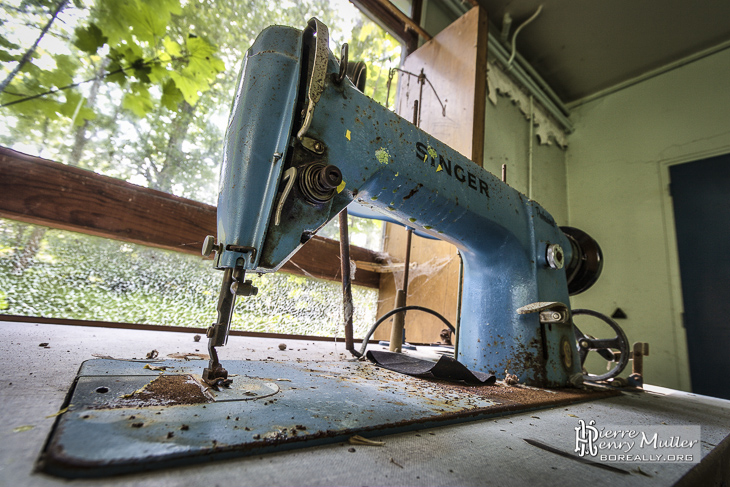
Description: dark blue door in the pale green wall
669,154,730,399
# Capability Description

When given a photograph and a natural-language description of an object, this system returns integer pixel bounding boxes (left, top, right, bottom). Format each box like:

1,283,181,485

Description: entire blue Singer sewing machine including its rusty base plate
42,19,628,477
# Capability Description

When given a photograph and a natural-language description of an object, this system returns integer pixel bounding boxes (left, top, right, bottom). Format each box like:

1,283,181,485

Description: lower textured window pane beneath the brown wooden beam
0,219,377,337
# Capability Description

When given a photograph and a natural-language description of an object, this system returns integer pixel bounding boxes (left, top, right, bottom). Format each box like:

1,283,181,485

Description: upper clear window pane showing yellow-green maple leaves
0,0,401,204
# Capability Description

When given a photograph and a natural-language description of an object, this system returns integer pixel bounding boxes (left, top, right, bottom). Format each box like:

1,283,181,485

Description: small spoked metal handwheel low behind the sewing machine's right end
572,309,630,382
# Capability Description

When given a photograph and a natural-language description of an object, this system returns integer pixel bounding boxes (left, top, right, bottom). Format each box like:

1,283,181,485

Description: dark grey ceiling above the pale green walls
478,0,730,104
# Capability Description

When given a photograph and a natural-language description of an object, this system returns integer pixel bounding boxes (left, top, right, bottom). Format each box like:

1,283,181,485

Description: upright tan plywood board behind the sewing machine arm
375,8,487,343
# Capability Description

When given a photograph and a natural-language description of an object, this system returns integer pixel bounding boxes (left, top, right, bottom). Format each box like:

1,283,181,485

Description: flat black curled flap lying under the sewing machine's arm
367,350,497,385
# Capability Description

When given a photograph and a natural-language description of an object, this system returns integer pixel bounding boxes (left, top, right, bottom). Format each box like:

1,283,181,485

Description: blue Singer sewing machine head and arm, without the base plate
204,19,602,386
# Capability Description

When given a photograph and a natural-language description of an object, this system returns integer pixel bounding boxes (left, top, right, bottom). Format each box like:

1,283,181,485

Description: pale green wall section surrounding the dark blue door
566,50,730,390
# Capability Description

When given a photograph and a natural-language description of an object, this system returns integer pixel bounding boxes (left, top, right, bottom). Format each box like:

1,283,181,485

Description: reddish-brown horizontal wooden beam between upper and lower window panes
0,147,383,288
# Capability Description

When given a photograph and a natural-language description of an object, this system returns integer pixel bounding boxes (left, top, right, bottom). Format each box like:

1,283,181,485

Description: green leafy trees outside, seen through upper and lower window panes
0,0,400,335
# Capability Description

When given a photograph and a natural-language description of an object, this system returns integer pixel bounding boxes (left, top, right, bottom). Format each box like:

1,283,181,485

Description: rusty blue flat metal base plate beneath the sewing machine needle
40,359,616,478
